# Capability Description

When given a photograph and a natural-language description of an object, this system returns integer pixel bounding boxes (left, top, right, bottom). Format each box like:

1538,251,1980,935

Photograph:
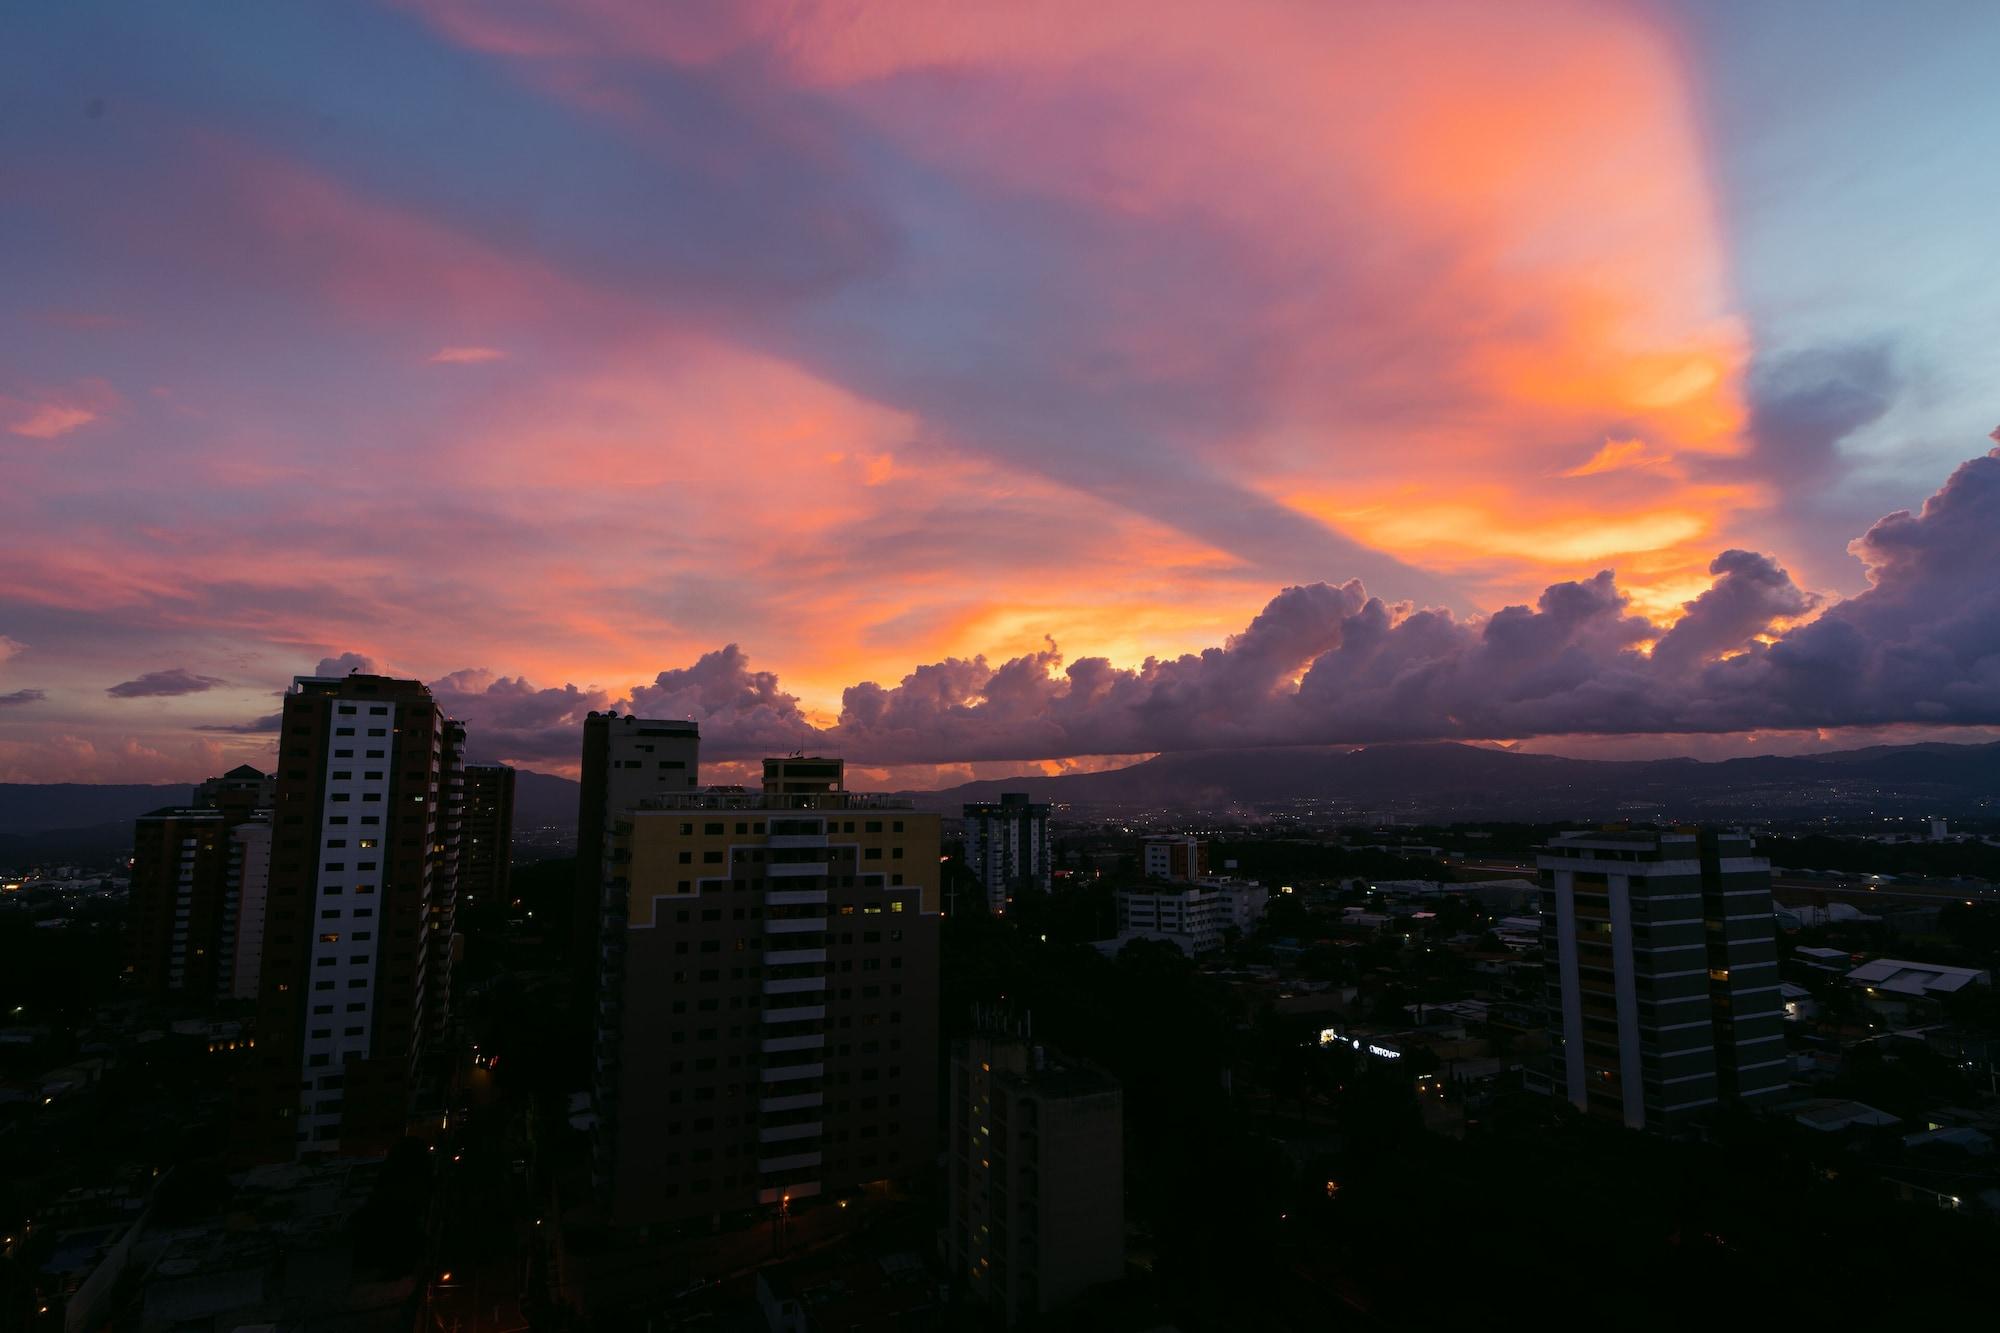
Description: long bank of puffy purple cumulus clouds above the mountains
484,448,2000,765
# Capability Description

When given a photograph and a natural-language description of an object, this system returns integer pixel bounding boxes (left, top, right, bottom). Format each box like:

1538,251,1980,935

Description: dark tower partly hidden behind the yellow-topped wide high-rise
570,713,702,991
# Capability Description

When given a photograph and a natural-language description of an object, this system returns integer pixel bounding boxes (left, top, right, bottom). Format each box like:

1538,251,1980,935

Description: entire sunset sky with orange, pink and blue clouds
0,0,2000,787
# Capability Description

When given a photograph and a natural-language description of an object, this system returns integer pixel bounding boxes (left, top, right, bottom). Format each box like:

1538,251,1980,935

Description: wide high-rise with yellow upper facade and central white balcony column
594,757,940,1225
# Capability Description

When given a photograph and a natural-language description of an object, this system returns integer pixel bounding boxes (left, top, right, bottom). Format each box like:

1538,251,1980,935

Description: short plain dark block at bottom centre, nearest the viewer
946,1037,1124,1325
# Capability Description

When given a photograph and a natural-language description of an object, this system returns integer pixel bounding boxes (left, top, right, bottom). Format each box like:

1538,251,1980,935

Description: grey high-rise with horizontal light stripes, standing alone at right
1540,831,1786,1129
